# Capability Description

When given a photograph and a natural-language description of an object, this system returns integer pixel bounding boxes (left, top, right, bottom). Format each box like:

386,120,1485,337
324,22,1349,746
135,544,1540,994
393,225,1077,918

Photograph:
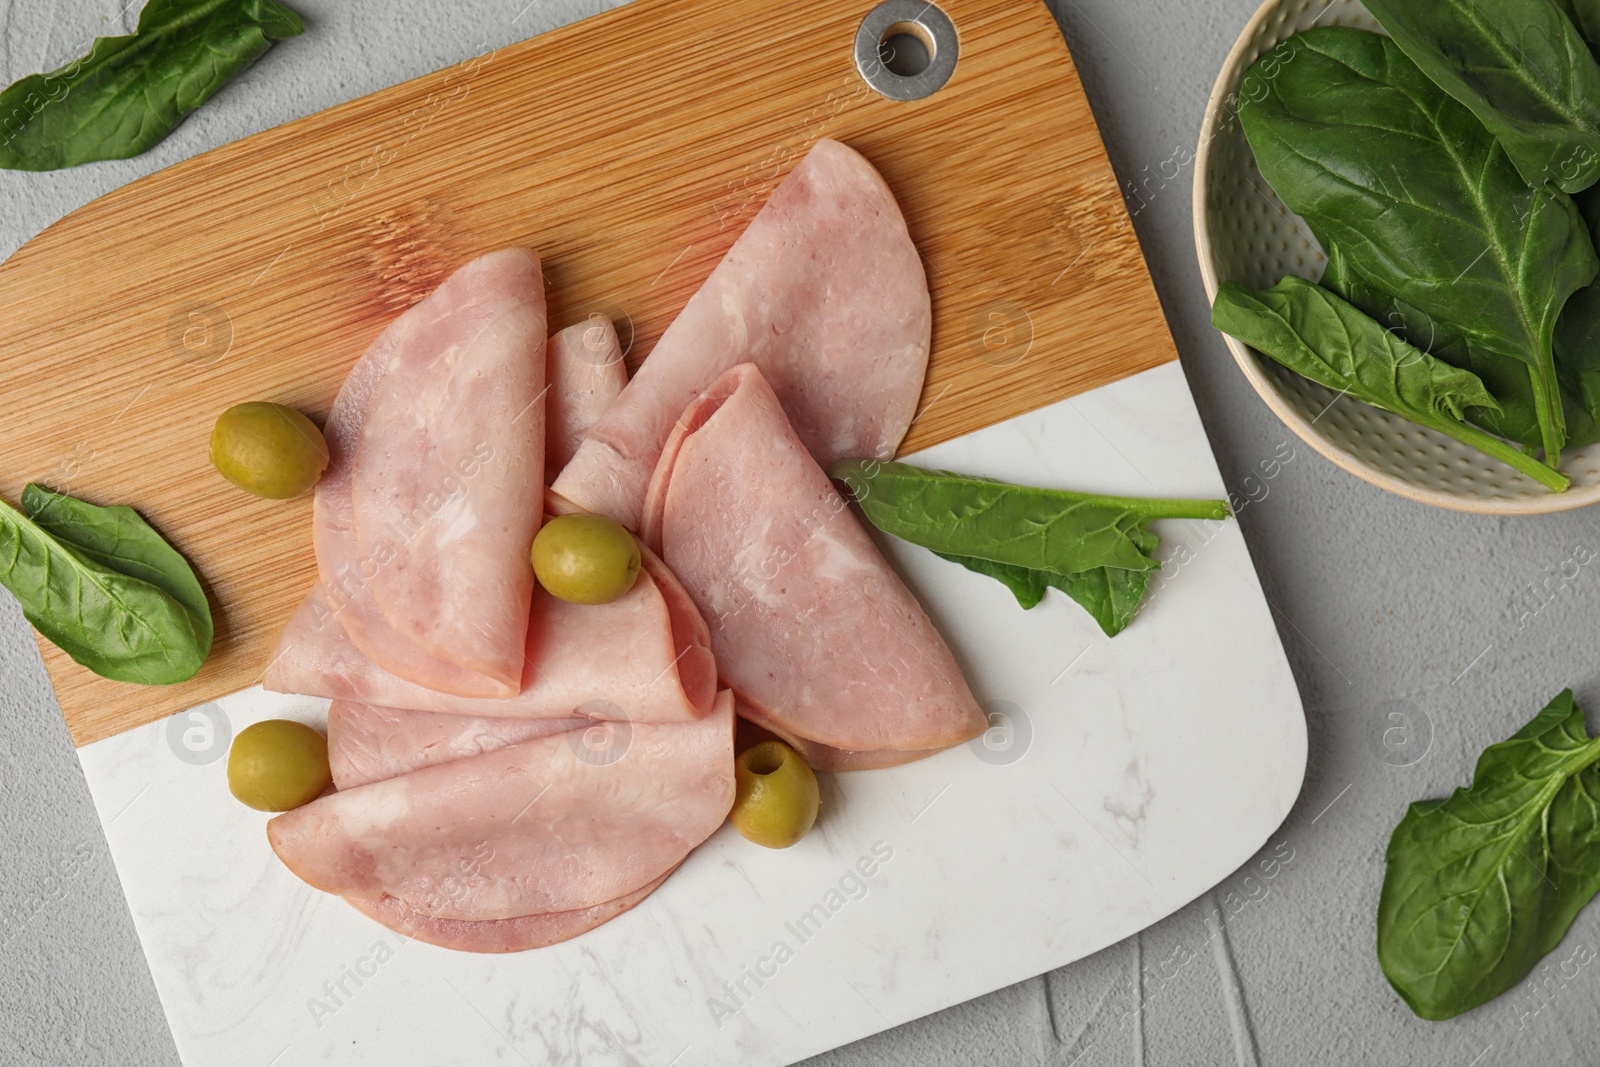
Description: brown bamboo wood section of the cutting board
0,0,1176,745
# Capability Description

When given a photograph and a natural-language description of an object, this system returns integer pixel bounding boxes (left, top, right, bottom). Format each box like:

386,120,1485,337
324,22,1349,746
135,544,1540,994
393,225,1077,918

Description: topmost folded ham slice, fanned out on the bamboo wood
554,139,933,530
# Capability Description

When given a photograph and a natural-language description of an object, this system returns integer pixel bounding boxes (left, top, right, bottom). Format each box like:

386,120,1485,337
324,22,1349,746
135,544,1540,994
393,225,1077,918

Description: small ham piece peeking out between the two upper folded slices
544,314,627,482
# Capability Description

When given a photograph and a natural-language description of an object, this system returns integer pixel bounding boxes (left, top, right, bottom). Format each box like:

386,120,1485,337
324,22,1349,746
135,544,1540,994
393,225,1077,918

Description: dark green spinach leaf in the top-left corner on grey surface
0,0,306,171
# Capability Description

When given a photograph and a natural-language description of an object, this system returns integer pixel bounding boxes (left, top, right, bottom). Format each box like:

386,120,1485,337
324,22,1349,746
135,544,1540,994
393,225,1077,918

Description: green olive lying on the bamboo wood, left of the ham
211,400,328,501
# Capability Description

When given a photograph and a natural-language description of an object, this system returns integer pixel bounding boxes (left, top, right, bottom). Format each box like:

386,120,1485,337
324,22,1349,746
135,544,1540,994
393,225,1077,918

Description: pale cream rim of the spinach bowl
1190,0,1600,515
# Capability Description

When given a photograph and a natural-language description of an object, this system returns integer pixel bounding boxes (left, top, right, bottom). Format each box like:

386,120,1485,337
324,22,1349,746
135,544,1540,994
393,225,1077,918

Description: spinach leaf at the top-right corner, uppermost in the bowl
1366,0,1600,192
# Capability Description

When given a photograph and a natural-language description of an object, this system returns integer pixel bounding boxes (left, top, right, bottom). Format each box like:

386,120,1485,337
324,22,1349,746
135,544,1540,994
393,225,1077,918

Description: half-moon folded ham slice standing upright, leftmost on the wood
314,248,546,696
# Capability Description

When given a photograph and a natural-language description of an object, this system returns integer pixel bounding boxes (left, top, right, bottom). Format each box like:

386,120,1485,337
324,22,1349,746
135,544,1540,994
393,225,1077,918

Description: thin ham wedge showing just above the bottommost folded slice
328,701,594,789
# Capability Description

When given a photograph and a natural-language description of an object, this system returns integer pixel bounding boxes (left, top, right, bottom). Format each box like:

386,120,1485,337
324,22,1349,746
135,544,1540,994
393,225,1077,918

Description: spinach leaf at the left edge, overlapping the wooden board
0,501,211,685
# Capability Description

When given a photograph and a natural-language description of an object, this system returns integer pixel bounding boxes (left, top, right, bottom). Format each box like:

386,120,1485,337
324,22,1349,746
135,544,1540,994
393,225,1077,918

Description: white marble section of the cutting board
78,363,1306,1067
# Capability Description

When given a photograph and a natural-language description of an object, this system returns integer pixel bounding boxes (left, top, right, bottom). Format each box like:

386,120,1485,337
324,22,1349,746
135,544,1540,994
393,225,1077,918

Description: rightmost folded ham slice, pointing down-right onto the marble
643,363,987,766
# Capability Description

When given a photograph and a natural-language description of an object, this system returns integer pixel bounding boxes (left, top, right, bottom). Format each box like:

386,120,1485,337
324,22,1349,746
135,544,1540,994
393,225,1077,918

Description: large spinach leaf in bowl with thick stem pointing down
1240,27,1600,467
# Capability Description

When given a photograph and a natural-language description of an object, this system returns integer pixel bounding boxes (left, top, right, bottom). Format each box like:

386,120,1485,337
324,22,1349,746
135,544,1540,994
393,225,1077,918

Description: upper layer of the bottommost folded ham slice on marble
267,691,734,921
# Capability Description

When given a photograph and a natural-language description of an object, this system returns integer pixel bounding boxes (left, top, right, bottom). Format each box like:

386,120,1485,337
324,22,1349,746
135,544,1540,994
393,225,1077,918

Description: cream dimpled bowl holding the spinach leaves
1194,0,1600,515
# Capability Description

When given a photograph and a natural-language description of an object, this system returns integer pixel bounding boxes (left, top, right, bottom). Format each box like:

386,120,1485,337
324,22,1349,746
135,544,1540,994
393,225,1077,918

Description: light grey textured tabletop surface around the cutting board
0,0,1600,1067
